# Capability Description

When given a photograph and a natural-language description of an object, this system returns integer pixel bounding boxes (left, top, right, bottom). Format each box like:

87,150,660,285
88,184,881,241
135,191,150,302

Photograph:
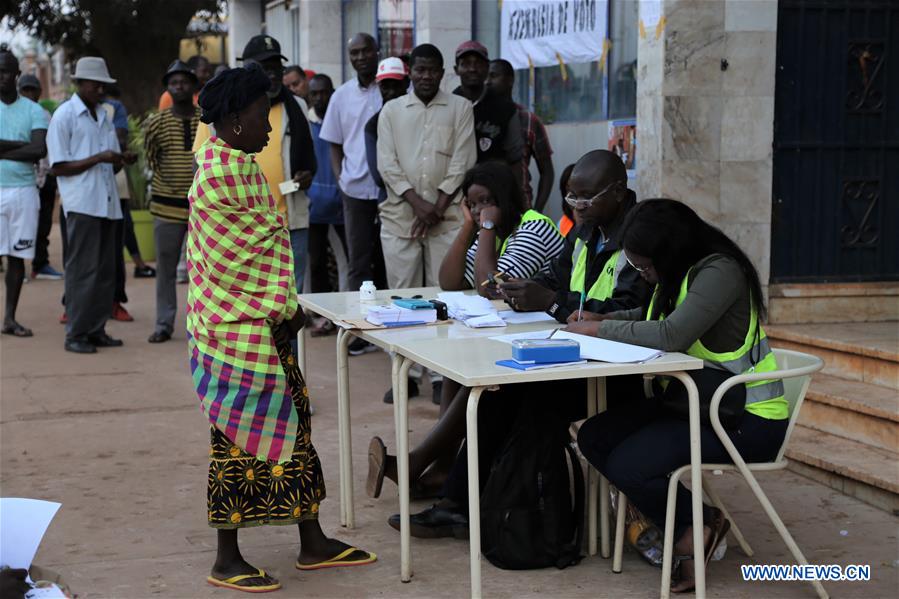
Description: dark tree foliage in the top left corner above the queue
0,0,224,112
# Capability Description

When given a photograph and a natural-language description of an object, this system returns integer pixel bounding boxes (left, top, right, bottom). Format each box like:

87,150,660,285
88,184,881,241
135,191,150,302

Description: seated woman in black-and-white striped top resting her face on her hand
366,162,564,497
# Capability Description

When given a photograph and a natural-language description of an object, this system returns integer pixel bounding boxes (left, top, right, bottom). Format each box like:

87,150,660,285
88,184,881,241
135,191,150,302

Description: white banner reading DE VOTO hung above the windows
500,0,608,69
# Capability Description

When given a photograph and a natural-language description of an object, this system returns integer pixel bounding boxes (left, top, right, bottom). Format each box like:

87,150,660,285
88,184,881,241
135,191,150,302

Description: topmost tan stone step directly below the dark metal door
768,282,899,324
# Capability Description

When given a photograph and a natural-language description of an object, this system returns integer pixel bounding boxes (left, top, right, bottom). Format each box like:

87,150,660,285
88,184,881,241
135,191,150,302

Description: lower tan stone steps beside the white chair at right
766,321,899,513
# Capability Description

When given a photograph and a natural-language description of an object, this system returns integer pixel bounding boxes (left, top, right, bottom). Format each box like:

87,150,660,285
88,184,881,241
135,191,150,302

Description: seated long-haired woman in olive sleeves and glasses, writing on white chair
567,199,789,592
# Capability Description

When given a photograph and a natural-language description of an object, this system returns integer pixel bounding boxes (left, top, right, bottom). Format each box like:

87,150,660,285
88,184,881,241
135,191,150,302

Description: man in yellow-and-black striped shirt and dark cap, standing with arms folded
144,60,200,343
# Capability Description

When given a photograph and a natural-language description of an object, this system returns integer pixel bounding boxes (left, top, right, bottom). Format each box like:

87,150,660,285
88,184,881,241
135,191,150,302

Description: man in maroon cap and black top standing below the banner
453,40,524,173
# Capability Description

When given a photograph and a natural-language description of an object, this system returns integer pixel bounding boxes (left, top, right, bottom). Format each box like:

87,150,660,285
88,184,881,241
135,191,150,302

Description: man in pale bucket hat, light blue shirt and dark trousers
47,56,135,354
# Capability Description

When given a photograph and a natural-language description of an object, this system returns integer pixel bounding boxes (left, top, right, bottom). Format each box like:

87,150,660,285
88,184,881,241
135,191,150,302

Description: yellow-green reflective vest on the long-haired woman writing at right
646,269,787,408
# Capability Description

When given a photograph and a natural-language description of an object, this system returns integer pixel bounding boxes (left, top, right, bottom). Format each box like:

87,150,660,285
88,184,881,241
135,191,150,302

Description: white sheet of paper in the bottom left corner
0,497,62,570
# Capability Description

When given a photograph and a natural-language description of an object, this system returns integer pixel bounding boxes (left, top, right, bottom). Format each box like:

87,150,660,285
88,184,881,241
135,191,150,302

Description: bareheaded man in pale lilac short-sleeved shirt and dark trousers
319,33,386,355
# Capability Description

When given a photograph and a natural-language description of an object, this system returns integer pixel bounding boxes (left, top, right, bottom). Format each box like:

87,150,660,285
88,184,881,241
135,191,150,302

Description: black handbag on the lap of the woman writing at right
656,367,746,430
